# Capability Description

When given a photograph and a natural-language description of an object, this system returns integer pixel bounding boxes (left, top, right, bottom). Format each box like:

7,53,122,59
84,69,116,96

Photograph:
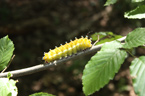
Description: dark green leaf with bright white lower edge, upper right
124,5,145,19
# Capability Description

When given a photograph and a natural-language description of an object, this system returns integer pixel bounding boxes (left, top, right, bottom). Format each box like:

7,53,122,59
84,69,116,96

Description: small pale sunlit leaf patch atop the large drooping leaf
101,41,123,51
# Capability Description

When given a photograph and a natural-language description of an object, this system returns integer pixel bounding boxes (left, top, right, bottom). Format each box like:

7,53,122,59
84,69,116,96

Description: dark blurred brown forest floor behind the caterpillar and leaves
0,0,145,96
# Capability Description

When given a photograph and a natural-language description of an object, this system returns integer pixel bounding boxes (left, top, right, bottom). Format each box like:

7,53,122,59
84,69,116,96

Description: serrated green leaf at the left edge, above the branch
0,36,14,71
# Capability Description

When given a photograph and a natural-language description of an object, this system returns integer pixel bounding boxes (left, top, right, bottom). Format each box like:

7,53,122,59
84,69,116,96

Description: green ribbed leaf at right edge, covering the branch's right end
123,28,145,49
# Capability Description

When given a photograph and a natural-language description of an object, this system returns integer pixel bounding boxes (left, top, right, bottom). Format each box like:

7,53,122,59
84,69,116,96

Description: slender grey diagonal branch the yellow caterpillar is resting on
0,36,126,77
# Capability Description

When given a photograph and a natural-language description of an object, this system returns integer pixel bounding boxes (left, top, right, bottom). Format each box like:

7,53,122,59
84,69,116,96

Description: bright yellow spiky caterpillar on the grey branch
42,36,92,63
